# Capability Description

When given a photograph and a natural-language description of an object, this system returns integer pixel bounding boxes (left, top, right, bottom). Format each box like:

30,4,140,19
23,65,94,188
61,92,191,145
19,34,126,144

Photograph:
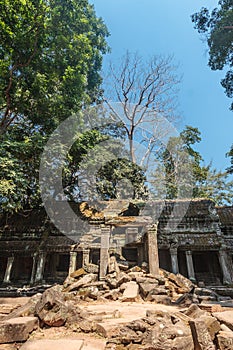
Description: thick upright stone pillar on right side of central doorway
148,224,159,276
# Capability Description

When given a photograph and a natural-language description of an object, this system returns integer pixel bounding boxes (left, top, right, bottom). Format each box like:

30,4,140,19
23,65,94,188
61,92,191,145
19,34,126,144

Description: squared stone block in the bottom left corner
0,317,38,344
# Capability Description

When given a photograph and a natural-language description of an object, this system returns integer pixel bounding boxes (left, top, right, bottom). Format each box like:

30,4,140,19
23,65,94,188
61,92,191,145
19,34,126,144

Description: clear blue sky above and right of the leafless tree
90,0,233,170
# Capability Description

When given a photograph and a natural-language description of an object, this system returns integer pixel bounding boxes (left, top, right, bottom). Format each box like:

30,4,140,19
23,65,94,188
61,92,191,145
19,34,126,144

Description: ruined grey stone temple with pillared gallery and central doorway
0,199,233,286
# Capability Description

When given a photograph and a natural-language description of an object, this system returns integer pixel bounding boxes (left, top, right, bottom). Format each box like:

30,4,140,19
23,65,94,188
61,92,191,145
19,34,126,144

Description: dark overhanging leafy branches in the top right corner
192,0,233,110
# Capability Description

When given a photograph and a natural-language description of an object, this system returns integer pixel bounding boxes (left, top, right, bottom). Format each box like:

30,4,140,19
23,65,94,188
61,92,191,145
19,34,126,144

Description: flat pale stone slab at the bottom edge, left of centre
20,339,83,350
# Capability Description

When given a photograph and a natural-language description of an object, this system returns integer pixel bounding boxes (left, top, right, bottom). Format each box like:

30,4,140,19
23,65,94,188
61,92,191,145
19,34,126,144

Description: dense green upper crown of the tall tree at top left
0,0,108,133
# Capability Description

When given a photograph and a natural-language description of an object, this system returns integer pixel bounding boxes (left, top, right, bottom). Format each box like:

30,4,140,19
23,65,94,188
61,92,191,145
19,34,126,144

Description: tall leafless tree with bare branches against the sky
105,52,179,168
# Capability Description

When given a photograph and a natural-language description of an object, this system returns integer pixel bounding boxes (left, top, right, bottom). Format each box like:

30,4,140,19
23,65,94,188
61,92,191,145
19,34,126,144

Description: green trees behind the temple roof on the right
152,126,233,205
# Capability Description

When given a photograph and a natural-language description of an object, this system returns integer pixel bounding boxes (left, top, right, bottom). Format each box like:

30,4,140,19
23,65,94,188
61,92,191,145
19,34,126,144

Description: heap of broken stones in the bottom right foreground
105,304,233,350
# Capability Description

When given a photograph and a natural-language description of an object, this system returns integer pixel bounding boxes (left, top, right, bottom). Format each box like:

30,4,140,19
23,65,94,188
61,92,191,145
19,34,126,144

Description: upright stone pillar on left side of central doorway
99,225,110,280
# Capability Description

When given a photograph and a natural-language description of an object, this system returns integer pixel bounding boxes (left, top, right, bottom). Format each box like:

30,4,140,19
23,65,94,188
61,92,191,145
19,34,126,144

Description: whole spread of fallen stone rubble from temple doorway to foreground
0,257,233,350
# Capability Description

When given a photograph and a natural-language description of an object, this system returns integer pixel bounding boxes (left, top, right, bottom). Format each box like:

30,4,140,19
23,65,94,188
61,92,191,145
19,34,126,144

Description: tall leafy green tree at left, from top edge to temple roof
0,0,108,210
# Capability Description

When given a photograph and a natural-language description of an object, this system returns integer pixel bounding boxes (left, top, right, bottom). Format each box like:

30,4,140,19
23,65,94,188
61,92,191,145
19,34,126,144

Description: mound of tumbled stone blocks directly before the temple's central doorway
63,256,226,307
